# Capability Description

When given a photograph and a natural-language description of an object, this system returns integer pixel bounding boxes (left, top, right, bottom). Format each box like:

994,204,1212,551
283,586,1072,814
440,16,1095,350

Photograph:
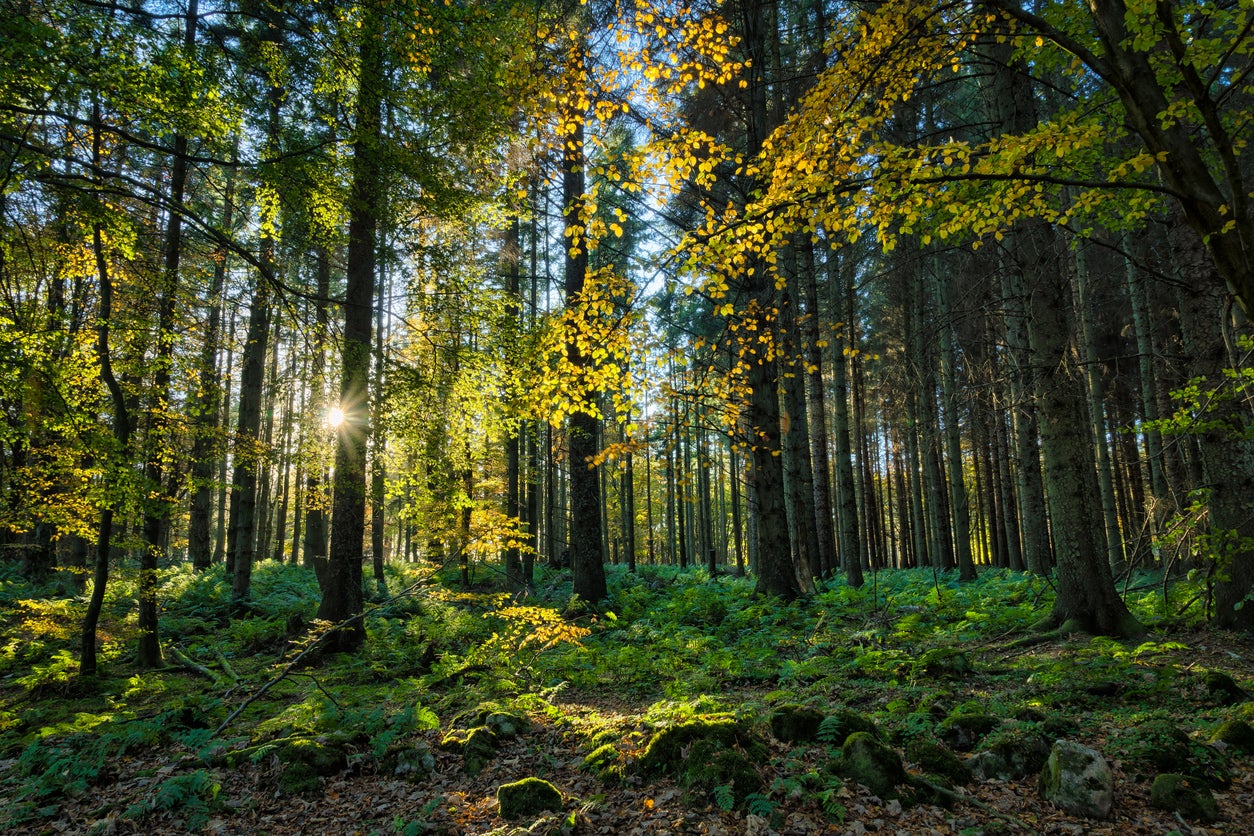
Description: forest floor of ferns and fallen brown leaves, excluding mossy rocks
0,568,1254,836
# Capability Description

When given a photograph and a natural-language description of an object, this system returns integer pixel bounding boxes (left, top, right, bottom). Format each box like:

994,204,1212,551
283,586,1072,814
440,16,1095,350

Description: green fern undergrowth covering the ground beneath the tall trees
0,562,1233,830
